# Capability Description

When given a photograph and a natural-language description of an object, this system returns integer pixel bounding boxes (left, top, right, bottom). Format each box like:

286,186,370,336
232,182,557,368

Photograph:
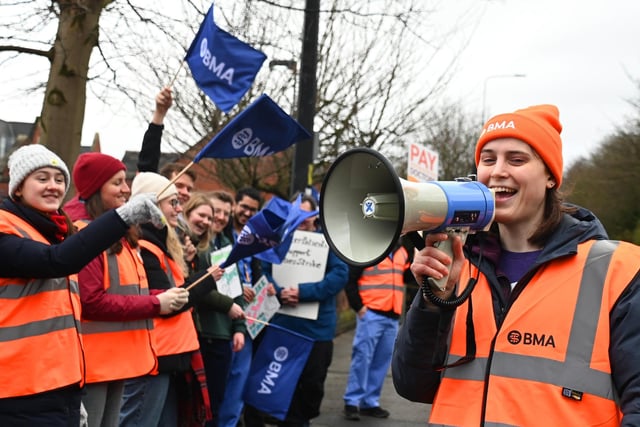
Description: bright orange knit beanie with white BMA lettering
476,104,562,187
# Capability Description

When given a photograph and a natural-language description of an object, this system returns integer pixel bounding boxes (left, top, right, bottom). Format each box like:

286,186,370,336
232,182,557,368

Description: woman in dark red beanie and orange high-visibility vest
65,152,189,427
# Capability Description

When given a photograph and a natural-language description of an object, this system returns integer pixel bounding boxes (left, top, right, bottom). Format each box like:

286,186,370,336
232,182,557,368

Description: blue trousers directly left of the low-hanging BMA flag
218,334,253,427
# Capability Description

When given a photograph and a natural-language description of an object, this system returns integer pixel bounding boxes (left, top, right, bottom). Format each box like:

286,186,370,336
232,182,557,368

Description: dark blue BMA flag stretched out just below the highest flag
193,94,311,163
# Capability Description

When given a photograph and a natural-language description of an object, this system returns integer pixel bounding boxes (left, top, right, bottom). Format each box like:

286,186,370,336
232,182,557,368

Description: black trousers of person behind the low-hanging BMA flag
244,341,333,427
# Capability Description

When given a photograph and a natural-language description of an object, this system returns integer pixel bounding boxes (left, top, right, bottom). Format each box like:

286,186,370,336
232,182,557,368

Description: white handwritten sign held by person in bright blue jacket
272,230,329,319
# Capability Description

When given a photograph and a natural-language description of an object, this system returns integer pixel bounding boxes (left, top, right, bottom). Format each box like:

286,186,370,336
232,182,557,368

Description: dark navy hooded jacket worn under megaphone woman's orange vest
391,208,640,426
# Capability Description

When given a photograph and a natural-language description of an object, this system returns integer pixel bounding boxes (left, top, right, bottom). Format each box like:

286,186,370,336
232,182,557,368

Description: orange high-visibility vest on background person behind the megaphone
358,246,410,314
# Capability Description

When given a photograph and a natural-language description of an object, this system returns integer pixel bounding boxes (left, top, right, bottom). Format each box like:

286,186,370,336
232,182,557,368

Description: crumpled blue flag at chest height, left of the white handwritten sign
220,197,289,268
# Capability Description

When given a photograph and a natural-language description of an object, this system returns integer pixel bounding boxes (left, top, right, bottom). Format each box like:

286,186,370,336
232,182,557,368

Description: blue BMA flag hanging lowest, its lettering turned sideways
244,324,313,421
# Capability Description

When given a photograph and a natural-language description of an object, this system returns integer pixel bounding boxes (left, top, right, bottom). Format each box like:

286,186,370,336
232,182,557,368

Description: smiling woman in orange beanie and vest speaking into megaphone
392,105,640,427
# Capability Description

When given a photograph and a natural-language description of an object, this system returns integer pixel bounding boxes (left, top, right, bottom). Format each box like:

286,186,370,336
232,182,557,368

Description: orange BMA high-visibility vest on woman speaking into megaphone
429,240,640,427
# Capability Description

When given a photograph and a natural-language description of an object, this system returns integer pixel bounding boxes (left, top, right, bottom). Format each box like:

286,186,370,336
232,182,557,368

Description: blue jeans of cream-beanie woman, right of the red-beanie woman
120,374,178,427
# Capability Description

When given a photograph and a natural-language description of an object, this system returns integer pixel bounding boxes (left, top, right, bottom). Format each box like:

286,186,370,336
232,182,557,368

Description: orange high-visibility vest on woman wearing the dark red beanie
74,221,158,384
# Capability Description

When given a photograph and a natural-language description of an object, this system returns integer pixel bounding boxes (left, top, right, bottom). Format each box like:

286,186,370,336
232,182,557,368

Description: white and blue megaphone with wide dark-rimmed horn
320,148,495,284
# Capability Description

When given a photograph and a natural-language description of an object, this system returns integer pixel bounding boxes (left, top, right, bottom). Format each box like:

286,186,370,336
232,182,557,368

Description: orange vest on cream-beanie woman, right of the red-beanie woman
139,240,200,356
